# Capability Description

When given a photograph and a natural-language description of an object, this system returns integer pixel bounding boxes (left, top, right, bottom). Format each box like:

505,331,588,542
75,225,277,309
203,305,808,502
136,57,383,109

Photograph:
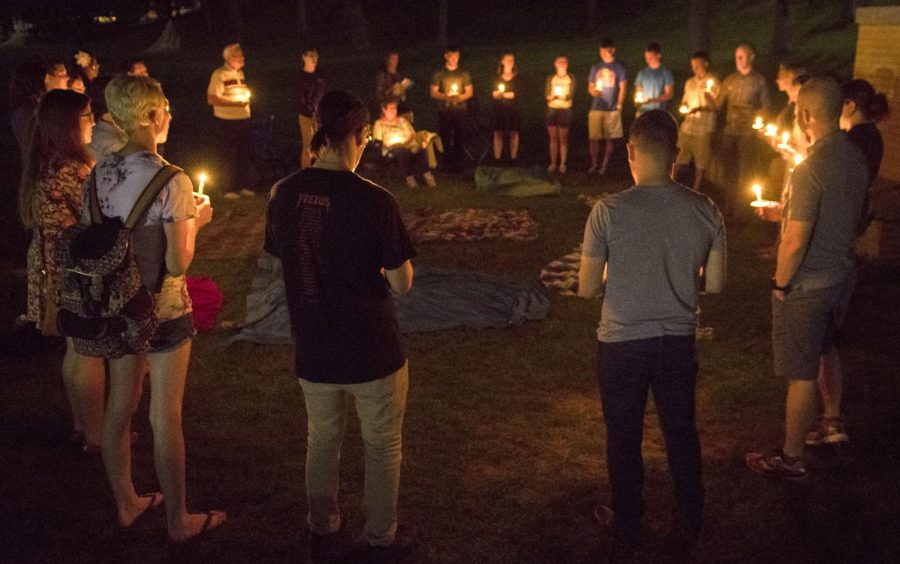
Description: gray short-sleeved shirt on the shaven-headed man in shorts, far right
782,131,869,290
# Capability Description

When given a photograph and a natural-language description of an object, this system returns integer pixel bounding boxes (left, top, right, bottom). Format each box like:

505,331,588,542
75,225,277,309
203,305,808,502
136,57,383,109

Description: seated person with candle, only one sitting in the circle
372,98,437,188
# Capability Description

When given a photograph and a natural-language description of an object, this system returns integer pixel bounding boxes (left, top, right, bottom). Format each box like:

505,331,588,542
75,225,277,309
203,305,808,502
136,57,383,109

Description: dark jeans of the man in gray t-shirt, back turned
597,335,703,539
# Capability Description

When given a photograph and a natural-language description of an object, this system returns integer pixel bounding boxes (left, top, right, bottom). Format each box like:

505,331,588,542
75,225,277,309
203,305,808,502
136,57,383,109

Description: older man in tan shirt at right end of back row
716,43,770,213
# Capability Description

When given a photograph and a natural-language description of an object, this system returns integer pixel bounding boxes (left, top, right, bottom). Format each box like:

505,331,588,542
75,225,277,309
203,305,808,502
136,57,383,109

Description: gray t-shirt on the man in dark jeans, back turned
581,183,725,342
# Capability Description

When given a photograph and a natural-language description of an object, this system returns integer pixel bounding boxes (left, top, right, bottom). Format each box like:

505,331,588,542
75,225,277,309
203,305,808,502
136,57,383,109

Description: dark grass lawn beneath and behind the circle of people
0,2,900,563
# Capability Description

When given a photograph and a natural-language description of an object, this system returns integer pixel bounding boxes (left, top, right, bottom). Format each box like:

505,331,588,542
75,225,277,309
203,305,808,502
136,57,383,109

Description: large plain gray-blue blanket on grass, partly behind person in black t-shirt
229,253,550,344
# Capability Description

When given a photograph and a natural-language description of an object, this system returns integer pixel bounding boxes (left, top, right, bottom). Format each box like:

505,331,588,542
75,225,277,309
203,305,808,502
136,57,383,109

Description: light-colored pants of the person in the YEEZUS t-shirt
300,363,409,546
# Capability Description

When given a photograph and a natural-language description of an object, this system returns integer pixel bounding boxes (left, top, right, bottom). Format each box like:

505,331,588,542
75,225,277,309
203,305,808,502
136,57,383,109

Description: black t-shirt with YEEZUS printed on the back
265,168,416,384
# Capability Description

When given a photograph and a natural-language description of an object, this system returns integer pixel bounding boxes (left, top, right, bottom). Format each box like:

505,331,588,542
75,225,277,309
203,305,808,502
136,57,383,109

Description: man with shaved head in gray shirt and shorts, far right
746,78,868,480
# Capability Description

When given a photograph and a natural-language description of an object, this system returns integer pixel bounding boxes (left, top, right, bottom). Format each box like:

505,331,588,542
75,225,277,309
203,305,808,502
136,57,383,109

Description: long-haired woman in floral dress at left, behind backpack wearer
19,90,106,454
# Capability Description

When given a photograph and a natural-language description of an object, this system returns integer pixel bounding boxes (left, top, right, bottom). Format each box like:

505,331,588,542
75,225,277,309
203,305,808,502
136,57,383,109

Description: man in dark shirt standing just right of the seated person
430,45,474,171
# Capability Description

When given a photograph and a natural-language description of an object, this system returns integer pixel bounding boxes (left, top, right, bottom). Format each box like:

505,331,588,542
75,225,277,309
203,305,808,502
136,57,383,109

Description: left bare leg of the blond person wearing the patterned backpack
102,355,147,527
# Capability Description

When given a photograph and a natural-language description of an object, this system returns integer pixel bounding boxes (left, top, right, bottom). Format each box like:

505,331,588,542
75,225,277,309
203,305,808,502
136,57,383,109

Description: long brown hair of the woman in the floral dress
19,90,94,228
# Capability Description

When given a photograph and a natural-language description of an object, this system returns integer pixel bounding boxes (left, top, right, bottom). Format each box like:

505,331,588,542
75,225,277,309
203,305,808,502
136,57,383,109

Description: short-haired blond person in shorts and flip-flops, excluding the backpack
87,76,226,543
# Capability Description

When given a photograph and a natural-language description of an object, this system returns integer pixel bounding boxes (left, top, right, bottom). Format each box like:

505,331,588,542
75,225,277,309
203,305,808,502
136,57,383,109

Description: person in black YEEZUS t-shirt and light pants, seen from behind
264,90,416,562
